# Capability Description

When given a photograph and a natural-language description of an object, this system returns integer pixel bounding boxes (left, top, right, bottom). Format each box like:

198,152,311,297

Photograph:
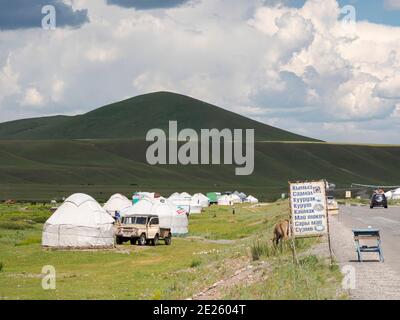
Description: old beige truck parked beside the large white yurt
115,215,172,246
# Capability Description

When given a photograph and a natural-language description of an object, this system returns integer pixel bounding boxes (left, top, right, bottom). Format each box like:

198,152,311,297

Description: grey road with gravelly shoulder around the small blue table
330,206,400,300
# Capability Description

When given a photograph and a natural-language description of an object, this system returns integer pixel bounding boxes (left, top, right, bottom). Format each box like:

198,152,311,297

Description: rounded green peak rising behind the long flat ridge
0,92,315,141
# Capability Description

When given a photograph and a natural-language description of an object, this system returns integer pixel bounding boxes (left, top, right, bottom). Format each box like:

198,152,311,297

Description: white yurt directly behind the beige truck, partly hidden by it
122,197,189,234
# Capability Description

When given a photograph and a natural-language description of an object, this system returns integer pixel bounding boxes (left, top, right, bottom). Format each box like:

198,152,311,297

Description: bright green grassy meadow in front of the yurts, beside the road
0,201,341,299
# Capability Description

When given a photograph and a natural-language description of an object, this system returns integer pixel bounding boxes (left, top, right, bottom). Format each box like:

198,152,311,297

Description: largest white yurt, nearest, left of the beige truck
42,193,114,249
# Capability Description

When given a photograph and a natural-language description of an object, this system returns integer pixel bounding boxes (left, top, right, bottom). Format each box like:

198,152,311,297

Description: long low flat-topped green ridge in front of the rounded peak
0,140,400,199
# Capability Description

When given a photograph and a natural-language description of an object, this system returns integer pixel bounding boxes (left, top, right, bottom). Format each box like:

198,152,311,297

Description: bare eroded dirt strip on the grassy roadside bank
191,260,269,300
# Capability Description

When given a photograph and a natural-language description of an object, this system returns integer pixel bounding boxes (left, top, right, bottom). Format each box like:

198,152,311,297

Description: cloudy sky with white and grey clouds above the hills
0,0,400,144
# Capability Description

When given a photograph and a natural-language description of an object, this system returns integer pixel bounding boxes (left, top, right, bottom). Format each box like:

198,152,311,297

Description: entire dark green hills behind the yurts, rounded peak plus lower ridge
0,92,400,200
